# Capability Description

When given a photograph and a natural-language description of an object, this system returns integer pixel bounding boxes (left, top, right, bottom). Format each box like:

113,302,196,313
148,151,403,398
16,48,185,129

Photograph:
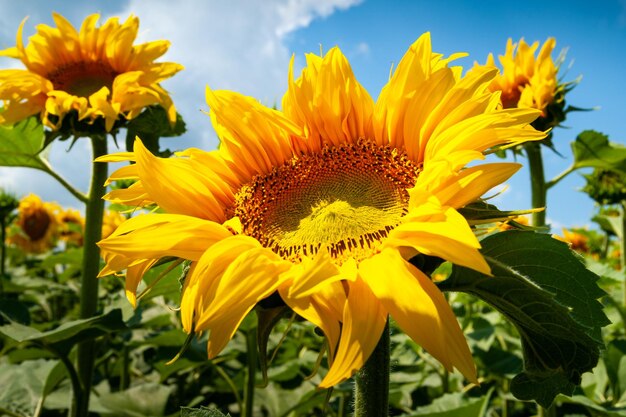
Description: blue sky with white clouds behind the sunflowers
0,0,626,232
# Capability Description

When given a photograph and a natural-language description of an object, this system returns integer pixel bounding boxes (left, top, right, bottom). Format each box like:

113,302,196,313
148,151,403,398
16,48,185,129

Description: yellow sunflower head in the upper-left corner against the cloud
0,13,182,132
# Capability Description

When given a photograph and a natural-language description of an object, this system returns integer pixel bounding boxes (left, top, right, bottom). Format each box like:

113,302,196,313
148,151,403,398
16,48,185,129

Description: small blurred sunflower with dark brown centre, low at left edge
7,194,61,253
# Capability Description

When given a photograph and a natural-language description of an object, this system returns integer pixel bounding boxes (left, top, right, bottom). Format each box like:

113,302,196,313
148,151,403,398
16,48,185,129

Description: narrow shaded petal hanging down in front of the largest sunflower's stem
320,278,387,388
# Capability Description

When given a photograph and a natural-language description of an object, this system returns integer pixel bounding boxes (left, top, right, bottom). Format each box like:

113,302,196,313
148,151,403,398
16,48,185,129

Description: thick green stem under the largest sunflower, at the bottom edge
354,319,389,417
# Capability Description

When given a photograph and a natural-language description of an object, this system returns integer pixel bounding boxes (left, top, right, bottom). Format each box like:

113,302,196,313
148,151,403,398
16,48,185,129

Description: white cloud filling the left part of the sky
0,0,360,205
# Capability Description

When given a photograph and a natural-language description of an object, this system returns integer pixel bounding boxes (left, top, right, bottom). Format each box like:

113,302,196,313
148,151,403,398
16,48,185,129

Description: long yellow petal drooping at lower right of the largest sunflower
359,249,476,382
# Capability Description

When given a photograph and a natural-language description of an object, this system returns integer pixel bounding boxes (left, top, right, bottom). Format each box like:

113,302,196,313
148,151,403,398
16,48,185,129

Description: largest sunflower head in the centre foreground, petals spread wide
99,34,545,387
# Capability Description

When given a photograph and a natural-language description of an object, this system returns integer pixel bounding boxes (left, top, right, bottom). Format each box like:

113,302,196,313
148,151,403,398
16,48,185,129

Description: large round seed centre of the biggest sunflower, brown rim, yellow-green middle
234,139,419,262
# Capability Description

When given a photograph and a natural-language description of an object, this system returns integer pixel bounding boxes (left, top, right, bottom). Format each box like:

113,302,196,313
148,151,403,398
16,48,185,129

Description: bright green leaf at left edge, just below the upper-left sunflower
0,117,47,169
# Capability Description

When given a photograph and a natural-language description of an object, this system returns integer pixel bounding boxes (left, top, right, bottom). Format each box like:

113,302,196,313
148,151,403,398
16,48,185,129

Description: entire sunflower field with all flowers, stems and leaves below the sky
0,6,626,417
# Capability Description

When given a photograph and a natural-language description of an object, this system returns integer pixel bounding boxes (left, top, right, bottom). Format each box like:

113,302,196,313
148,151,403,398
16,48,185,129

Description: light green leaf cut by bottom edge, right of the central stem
410,389,493,417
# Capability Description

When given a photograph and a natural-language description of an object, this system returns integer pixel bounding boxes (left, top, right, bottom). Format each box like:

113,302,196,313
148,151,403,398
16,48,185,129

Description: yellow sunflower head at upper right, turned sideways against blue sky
486,38,559,117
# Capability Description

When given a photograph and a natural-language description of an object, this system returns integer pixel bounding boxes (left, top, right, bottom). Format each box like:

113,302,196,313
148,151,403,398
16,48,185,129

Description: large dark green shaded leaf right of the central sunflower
438,231,609,408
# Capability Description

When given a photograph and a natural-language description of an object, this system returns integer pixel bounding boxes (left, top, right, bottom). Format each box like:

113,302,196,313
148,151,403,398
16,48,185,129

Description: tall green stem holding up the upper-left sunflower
77,138,107,417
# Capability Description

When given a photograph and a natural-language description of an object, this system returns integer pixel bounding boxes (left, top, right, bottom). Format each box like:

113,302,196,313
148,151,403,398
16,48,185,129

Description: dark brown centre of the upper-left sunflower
47,61,118,97
